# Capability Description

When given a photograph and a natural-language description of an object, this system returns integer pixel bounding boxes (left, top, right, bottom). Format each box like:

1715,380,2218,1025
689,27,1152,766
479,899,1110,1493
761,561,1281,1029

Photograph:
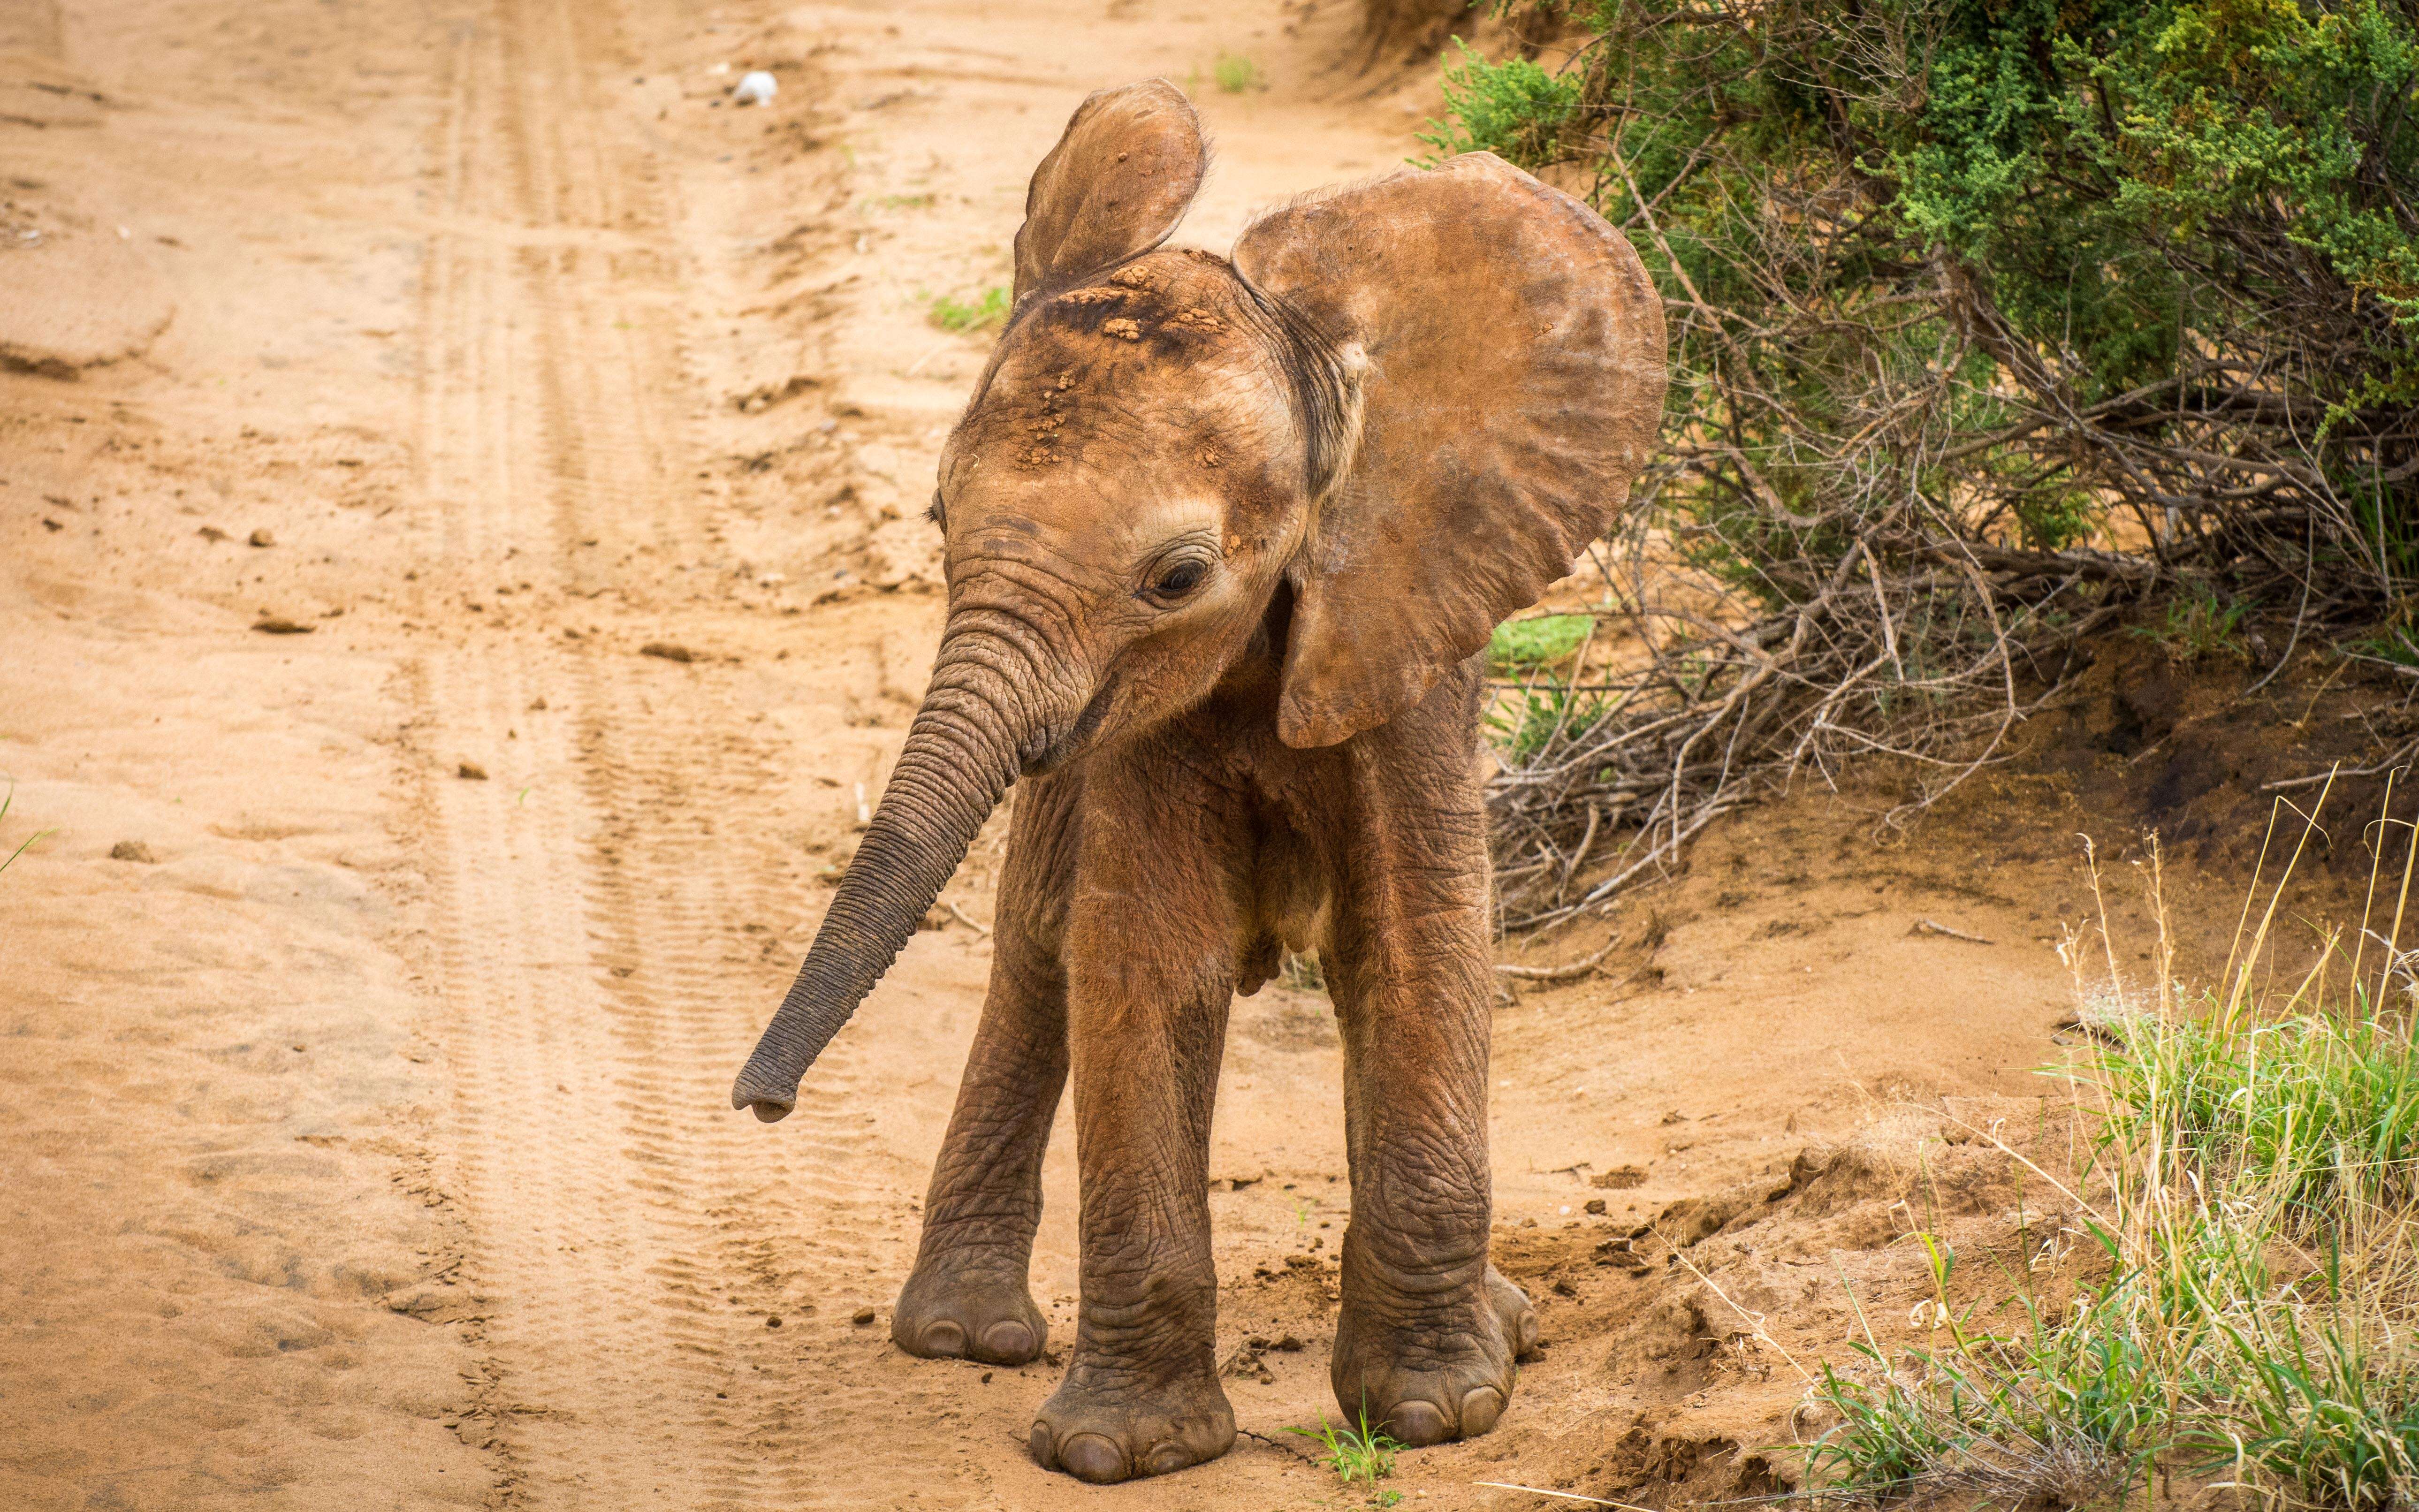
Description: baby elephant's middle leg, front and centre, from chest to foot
1033,774,1234,1483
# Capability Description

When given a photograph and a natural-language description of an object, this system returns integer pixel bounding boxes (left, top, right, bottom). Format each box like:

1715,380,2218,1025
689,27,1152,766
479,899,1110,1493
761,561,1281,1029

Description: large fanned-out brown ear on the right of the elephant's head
1234,152,1664,745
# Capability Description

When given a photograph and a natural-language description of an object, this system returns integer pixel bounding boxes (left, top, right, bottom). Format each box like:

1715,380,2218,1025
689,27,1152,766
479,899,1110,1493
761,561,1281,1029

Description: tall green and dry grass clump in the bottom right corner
1810,779,2419,1510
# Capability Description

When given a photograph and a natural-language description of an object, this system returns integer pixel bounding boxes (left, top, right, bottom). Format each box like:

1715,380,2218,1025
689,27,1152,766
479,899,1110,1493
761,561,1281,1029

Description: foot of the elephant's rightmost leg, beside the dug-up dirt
1331,1265,1538,1449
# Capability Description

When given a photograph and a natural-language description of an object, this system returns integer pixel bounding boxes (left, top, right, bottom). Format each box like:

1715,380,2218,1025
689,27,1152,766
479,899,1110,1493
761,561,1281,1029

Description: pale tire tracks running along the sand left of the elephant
409,0,914,1507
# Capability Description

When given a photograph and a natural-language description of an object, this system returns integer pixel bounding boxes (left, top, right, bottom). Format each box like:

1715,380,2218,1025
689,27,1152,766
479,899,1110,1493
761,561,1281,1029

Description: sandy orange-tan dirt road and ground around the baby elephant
0,0,2138,1510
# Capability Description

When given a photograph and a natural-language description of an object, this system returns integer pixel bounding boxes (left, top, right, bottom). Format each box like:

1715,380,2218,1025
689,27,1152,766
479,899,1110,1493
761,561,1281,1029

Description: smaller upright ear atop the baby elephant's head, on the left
1016,80,1210,303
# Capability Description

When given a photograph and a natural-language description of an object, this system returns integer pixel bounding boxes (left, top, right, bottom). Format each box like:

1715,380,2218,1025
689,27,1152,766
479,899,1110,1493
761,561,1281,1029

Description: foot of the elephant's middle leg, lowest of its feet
1030,1357,1234,1485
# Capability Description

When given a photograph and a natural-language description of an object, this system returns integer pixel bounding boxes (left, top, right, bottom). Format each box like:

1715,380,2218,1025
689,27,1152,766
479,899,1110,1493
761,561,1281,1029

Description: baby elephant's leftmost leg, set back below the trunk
890,779,1076,1364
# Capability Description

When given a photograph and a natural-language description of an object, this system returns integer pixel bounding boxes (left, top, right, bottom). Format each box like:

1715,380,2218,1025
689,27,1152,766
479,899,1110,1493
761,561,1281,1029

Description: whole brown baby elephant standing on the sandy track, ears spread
730,82,1664,1481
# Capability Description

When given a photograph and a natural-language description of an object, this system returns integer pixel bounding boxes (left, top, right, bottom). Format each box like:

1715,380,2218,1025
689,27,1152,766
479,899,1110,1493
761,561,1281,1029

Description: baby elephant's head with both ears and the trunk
730,82,1664,1120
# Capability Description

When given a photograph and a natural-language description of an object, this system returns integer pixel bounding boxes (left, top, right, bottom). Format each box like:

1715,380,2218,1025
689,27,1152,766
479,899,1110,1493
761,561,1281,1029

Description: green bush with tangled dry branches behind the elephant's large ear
1425,0,2419,922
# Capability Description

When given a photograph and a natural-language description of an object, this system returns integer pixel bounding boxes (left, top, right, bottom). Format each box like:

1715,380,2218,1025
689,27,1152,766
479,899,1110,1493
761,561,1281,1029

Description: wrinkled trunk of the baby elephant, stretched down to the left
730,627,1065,1123
